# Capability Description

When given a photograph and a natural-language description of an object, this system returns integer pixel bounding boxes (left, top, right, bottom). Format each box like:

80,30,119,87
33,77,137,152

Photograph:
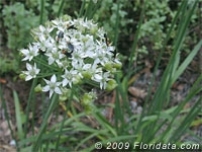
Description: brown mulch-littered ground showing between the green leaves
0,52,202,152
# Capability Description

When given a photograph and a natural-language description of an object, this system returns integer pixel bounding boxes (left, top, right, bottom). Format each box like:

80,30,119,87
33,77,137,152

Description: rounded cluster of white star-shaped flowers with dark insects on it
21,17,121,97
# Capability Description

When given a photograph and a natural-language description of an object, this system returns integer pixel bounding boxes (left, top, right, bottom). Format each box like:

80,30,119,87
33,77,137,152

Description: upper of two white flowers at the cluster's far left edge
21,45,39,61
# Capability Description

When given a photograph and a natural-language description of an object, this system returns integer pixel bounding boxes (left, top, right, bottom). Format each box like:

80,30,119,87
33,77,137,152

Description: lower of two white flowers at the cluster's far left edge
23,63,40,81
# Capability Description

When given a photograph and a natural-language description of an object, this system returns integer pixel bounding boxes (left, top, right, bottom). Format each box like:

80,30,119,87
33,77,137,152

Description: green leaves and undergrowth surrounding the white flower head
0,0,202,152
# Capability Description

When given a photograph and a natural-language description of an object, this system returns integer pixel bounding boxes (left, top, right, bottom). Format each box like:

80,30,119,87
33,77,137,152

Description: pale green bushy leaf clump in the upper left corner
3,2,37,50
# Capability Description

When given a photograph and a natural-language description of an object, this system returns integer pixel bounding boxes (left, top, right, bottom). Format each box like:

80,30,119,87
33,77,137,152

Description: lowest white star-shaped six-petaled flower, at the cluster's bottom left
42,75,62,98
